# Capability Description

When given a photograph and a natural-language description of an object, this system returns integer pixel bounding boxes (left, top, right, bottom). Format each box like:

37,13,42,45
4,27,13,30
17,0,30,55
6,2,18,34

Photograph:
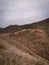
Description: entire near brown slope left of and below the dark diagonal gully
0,33,49,65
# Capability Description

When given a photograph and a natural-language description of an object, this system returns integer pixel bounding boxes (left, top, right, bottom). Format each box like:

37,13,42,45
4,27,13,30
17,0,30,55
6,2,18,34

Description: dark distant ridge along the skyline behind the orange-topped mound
0,18,49,36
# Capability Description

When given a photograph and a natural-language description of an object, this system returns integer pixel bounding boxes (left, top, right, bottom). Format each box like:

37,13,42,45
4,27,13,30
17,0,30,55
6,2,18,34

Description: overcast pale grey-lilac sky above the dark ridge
0,0,49,27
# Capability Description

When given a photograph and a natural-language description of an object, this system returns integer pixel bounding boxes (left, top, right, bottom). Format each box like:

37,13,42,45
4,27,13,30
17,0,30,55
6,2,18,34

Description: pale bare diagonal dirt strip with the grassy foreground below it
0,39,49,65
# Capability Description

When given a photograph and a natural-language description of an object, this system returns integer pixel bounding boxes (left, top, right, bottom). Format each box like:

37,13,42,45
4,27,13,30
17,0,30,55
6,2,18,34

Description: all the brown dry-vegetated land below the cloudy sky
0,19,49,65
